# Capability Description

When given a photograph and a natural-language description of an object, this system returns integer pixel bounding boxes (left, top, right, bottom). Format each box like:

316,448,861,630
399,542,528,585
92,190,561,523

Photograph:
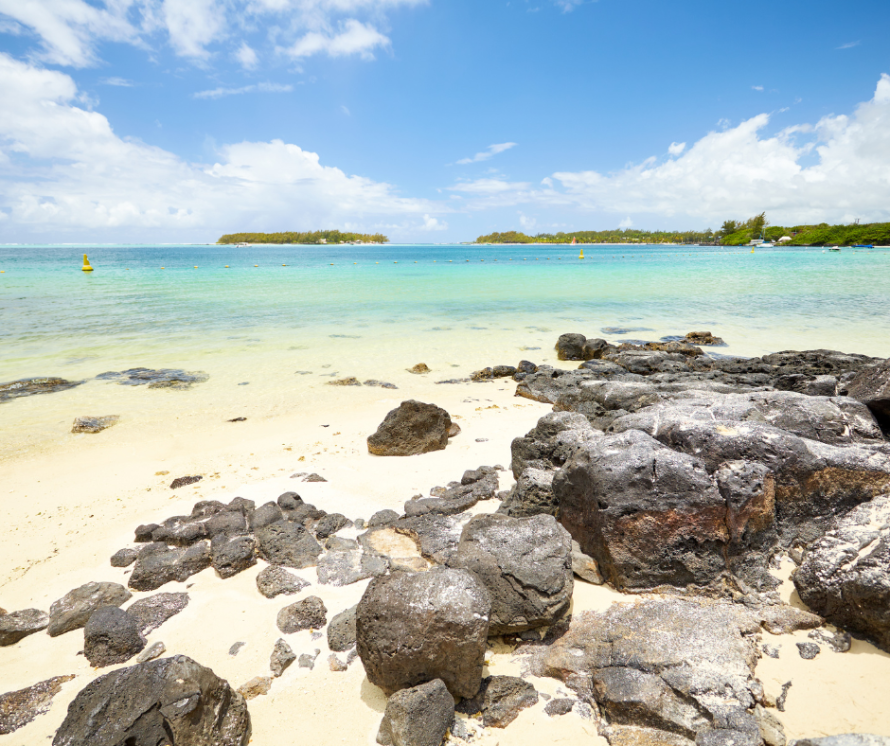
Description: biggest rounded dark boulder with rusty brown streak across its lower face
553,430,748,588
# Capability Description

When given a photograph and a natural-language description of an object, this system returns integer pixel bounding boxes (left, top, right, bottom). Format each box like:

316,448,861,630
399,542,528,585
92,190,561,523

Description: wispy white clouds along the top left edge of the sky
0,0,427,69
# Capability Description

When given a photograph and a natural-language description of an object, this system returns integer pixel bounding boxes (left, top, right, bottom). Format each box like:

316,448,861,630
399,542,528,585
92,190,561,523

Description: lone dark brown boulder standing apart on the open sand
368,399,451,456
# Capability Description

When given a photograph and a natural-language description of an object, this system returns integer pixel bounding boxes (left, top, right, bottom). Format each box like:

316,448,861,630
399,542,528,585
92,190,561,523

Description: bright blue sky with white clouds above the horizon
0,0,890,242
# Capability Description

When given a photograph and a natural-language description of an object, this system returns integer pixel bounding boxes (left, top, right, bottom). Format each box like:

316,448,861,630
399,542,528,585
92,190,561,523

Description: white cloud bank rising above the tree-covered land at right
452,74,890,225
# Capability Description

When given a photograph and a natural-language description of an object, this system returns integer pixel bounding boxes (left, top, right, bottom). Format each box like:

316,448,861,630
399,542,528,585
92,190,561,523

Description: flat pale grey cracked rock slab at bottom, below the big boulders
541,599,759,746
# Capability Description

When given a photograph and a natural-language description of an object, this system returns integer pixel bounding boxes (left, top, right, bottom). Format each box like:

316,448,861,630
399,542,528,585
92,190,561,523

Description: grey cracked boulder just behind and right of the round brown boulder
452,515,574,635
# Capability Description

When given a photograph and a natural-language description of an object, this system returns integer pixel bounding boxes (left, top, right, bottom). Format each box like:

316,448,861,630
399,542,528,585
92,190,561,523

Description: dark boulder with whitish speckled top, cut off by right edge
794,495,890,652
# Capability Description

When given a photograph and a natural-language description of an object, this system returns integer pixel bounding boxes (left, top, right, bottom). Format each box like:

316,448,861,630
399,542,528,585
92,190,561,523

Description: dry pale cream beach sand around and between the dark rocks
0,371,890,746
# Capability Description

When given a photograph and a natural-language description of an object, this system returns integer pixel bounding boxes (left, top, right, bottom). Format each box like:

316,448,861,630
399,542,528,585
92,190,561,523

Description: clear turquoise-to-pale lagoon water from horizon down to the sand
0,245,890,457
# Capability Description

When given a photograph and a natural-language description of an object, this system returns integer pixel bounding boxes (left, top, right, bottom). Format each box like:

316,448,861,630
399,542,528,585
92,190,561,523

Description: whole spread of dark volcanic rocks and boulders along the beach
0,333,890,746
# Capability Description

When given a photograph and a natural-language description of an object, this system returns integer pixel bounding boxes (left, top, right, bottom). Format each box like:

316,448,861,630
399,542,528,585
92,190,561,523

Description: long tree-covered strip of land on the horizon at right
476,213,890,246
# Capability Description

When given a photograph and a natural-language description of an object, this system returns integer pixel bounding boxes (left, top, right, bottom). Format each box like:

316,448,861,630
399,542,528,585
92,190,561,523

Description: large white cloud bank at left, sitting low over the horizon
0,53,444,241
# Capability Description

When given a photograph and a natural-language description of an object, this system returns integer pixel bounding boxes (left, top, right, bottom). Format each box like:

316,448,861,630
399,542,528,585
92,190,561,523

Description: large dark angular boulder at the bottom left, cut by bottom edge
53,655,251,746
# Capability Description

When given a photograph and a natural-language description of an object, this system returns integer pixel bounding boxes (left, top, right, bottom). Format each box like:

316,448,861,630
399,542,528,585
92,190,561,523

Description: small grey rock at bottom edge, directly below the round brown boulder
377,679,454,746
